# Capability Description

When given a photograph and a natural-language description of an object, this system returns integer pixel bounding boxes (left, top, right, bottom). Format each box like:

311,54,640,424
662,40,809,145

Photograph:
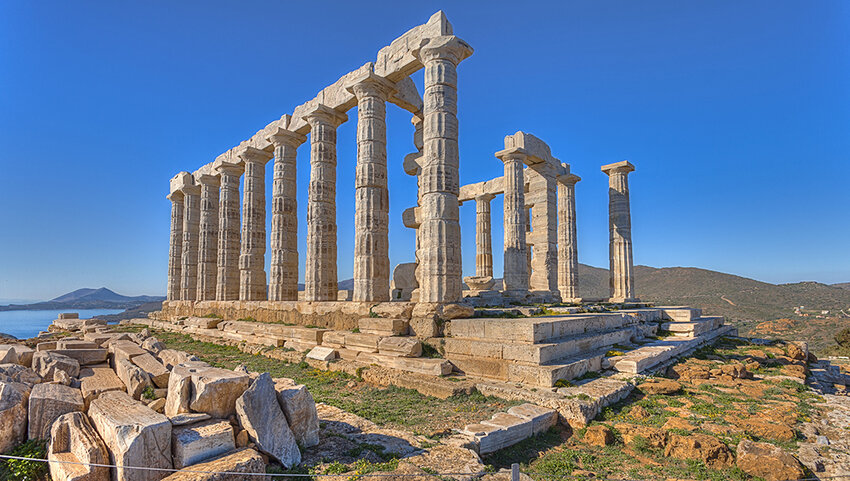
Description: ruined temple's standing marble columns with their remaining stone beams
164,12,637,316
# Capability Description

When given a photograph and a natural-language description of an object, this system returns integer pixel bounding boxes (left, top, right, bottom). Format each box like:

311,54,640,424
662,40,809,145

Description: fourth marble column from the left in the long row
215,162,244,301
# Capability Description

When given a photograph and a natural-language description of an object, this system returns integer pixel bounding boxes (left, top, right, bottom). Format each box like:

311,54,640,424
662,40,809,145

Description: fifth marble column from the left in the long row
239,147,272,301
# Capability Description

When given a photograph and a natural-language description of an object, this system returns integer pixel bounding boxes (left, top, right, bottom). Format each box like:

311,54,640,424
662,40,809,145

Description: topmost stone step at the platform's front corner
449,313,638,344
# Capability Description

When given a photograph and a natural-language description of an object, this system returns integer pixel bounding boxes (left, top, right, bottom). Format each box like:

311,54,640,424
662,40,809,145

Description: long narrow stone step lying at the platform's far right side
609,326,737,374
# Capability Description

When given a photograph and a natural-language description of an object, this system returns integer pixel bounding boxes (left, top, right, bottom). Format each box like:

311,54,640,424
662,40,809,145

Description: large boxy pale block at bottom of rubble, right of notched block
89,392,172,481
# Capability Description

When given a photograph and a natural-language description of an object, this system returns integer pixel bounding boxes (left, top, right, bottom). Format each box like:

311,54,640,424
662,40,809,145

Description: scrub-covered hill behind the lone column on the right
579,264,850,320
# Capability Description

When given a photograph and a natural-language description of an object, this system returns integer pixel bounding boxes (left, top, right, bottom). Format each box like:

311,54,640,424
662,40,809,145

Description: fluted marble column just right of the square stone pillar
558,174,581,302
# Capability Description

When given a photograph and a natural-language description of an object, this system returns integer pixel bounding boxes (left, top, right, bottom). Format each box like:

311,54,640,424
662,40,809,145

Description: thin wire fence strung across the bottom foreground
0,455,850,481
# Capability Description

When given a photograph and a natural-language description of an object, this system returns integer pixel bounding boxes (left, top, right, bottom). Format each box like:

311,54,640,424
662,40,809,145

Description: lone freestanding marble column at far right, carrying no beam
602,160,637,302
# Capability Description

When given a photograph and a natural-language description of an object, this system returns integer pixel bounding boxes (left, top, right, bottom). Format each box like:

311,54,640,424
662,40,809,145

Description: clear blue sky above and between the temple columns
0,0,850,299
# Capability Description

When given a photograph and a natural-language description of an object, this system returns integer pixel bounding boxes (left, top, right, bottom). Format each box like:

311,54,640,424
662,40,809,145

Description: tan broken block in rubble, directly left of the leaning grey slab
165,361,249,418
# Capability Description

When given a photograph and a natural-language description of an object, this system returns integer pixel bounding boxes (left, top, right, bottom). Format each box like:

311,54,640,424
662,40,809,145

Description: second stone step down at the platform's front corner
444,327,636,364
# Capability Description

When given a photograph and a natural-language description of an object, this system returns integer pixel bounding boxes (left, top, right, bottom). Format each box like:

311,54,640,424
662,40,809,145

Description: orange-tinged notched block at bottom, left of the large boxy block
47,412,109,481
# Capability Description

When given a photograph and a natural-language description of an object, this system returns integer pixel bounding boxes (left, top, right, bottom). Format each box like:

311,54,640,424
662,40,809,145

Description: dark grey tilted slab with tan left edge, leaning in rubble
236,373,301,468
